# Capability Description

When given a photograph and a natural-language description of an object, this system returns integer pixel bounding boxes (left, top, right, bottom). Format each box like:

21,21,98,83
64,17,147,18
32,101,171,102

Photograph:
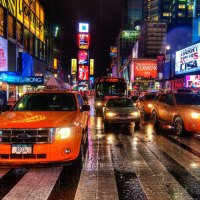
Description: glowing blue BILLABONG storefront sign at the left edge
0,72,44,85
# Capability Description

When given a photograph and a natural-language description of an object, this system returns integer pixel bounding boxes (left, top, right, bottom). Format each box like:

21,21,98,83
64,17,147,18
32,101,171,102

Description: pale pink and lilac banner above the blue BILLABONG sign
0,37,8,71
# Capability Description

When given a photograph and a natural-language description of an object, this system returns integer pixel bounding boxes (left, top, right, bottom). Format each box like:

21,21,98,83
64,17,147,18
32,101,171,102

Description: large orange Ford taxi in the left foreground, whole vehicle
0,90,90,165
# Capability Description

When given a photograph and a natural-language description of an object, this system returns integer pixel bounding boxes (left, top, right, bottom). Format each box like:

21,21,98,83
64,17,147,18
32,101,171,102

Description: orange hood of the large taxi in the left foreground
0,111,80,128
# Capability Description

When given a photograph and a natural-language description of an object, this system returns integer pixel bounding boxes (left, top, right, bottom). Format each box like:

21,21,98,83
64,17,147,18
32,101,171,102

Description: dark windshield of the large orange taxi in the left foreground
12,93,77,111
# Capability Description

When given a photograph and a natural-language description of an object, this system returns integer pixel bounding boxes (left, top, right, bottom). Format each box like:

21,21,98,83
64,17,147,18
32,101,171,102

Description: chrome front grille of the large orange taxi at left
0,129,53,144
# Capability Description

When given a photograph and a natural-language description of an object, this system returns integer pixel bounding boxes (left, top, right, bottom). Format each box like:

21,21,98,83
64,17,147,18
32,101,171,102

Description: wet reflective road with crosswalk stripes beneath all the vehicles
0,99,200,200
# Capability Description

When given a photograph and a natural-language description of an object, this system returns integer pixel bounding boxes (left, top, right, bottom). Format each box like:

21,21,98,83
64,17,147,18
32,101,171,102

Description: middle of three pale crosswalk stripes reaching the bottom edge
75,116,119,200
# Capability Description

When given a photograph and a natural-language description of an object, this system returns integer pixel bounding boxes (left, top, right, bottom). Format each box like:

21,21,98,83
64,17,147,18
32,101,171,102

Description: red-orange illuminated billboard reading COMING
130,59,157,81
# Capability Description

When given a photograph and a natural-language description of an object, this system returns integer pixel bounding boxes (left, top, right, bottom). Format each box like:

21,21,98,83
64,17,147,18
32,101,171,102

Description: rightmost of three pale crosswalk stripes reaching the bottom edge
120,135,192,200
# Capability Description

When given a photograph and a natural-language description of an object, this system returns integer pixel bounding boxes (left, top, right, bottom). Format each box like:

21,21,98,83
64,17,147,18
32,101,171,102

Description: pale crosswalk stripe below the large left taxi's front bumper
3,167,62,200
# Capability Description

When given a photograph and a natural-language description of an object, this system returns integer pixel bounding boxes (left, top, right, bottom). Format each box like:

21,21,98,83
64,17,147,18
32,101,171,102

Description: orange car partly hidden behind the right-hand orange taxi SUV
136,93,157,117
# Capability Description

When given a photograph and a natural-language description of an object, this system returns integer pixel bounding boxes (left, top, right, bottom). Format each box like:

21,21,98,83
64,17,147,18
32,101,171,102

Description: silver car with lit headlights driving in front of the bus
103,97,140,127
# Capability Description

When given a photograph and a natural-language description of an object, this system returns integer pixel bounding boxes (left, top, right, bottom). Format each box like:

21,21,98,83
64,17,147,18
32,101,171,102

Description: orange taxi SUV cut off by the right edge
151,92,200,135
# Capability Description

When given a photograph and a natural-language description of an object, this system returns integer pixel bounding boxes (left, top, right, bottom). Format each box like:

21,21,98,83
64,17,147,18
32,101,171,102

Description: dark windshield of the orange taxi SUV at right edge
175,93,200,105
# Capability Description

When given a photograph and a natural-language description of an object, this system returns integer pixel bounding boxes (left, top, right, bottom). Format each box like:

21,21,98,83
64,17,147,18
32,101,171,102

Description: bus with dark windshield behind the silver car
94,76,127,113
